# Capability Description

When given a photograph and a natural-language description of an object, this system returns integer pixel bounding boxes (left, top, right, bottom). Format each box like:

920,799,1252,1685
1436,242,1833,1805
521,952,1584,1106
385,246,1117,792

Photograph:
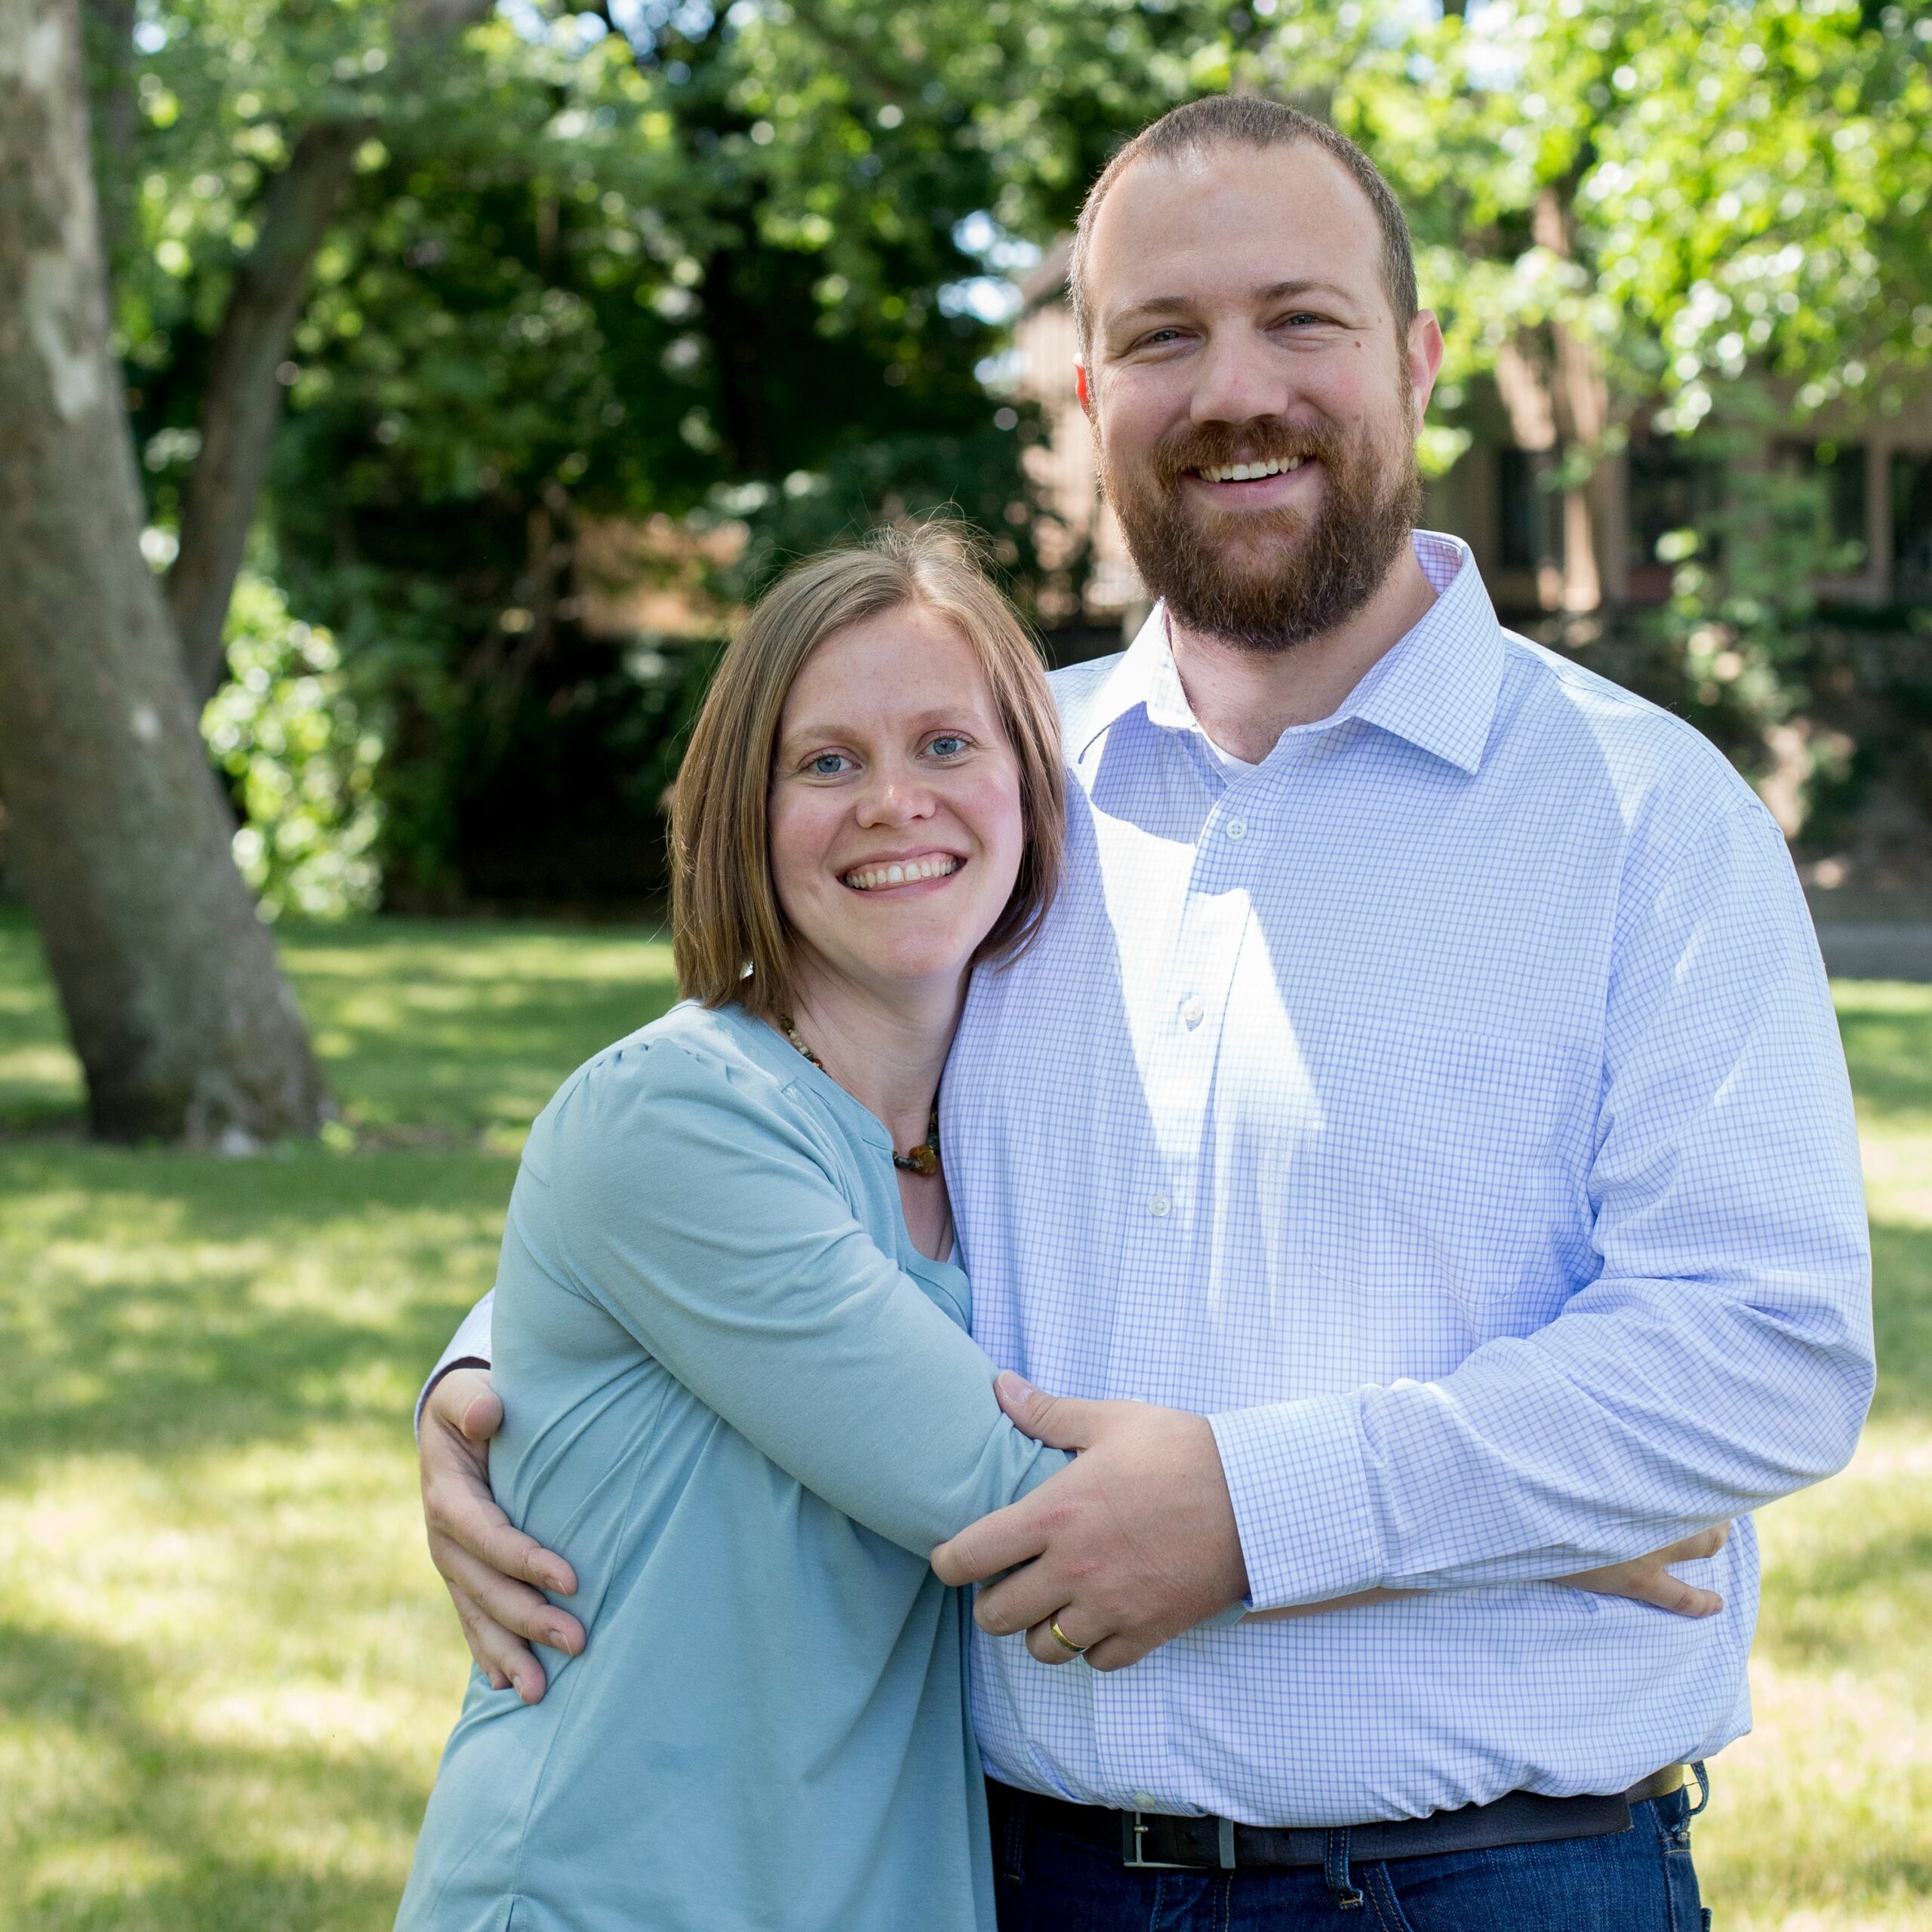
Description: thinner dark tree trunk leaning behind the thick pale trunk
168,122,369,703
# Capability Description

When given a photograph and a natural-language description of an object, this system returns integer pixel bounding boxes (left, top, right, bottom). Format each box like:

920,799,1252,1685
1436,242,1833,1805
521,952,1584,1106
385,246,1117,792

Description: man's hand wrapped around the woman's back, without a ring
415,1367,583,1704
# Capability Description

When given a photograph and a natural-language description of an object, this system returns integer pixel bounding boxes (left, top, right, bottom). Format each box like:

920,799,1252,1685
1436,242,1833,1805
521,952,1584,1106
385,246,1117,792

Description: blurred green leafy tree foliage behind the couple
91,0,1932,910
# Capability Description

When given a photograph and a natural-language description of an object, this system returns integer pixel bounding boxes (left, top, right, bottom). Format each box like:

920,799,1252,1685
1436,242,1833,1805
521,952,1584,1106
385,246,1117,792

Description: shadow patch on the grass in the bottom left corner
0,1623,423,1932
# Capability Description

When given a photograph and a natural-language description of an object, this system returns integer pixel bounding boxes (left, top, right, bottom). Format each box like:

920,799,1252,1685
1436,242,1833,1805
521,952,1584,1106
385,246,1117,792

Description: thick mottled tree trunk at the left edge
0,0,323,1146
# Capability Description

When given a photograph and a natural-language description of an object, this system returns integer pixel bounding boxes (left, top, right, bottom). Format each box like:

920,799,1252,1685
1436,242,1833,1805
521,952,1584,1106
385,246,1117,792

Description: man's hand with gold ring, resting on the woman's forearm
933,1372,1248,1671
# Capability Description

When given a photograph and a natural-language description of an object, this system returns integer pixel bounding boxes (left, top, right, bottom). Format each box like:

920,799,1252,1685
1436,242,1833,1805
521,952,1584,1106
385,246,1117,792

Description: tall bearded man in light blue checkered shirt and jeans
425,99,1872,1932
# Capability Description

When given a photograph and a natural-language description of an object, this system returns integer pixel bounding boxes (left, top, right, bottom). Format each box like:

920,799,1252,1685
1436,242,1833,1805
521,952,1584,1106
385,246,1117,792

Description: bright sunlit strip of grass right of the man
1697,983,1932,1932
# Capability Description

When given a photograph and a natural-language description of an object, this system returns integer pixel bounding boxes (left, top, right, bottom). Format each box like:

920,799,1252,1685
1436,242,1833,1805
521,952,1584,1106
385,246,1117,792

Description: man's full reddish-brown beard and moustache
1101,410,1422,653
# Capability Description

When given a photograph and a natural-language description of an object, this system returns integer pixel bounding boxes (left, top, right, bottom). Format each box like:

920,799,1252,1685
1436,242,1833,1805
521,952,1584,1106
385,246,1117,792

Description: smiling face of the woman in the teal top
771,605,1024,997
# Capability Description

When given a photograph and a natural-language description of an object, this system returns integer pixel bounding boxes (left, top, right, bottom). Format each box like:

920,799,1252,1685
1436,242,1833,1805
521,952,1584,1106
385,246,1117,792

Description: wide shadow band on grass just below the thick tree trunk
0,1144,516,1486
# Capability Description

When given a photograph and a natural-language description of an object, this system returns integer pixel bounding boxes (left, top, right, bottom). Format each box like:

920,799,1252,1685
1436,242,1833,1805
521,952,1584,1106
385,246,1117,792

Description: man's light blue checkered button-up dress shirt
943,534,1872,1824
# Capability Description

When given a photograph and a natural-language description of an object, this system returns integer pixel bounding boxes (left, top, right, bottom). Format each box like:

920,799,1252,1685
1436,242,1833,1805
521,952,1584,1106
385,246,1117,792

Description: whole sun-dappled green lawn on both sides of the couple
0,912,1932,1932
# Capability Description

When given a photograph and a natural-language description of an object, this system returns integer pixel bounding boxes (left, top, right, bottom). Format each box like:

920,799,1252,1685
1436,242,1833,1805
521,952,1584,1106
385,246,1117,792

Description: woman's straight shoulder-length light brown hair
670,524,1066,1018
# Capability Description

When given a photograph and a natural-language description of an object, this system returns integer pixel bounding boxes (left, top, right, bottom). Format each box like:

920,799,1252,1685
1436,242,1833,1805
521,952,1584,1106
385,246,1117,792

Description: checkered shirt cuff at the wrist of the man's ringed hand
1208,1393,1386,1609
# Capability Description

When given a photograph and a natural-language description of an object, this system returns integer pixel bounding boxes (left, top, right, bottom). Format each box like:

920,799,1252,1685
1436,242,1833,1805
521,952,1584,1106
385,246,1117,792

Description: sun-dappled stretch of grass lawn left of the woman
0,914,688,1932
